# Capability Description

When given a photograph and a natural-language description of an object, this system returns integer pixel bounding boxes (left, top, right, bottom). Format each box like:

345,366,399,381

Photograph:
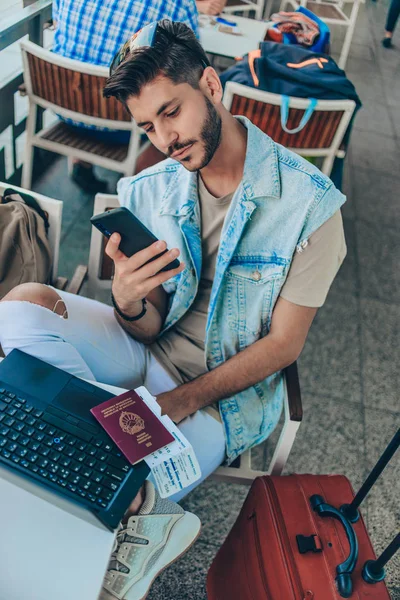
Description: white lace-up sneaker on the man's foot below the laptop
99,480,201,600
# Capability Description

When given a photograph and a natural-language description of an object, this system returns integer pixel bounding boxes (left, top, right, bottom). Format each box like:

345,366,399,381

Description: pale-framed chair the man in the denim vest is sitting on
88,194,303,484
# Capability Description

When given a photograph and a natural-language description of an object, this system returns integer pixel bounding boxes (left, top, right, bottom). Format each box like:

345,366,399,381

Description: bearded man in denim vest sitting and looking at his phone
0,20,346,600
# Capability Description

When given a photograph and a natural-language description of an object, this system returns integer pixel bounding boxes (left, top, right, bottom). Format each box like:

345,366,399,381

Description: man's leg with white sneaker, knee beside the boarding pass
99,410,225,600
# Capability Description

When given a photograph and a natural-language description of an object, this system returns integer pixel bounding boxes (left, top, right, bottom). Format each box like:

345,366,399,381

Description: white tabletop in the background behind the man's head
200,14,271,58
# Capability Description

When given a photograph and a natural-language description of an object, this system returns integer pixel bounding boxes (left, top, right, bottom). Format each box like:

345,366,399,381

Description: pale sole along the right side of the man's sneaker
124,512,201,600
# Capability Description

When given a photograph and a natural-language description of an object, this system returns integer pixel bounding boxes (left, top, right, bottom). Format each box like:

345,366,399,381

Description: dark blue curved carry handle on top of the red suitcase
310,494,358,598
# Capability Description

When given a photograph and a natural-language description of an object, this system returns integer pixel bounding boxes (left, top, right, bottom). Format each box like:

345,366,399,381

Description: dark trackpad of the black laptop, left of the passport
52,379,113,422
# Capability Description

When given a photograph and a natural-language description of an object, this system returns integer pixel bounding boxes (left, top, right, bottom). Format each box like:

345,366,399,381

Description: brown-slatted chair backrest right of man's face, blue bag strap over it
223,81,356,175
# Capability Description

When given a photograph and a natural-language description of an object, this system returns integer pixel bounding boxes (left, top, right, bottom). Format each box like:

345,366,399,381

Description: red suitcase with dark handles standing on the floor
207,429,400,600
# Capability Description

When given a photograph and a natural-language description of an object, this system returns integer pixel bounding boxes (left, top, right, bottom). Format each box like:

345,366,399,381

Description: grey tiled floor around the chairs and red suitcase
35,0,400,600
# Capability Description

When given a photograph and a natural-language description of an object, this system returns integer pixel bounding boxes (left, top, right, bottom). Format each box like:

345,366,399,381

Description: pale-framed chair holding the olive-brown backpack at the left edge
0,181,87,294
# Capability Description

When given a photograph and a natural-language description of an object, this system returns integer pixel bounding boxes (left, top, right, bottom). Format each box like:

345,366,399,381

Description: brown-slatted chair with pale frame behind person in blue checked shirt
21,41,147,189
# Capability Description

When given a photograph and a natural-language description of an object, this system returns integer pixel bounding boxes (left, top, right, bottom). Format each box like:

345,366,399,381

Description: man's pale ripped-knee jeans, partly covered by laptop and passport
0,290,225,502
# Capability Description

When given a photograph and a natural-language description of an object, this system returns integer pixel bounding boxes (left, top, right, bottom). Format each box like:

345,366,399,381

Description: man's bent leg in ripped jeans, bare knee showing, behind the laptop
0,283,148,389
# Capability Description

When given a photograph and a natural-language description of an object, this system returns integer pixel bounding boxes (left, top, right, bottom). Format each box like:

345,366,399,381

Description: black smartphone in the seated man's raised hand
90,207,180,271
